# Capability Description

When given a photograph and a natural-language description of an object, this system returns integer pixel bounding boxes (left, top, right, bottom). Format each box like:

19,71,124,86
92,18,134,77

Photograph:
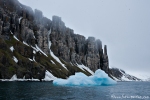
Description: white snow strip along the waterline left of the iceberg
0,70,57,82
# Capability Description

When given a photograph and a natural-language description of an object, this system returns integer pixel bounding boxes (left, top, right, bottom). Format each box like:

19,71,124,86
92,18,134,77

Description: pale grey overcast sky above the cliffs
19,0,150,75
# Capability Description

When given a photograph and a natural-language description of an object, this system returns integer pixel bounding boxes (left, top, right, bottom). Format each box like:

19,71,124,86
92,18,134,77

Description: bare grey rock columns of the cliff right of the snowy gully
50,16,108,72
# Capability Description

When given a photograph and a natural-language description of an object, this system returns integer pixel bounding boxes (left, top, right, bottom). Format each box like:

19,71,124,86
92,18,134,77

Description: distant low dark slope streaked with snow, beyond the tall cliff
110,68,142,81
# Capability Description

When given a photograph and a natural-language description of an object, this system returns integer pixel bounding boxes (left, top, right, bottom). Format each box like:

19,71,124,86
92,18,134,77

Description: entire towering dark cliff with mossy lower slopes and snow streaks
0,0,109,79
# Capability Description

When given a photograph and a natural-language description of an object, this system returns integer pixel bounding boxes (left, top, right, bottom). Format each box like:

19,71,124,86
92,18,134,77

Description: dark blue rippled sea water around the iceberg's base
0,82,150,100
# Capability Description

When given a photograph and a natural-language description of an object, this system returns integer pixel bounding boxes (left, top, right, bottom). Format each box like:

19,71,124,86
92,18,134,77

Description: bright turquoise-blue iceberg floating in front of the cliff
53,69,117,86
